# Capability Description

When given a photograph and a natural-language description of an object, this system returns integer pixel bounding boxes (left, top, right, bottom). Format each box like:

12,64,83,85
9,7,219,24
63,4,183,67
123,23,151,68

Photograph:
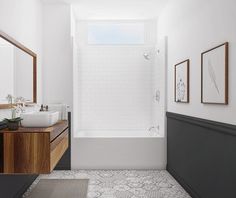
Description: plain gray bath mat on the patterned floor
27,179,88,198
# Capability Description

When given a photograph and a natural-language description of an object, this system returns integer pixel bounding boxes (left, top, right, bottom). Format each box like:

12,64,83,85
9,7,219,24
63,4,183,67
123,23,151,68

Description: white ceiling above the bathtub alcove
43,0,168,19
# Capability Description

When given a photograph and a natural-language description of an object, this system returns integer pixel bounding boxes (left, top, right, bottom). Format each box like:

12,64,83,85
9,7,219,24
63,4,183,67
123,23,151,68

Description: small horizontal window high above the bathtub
88,22,145,45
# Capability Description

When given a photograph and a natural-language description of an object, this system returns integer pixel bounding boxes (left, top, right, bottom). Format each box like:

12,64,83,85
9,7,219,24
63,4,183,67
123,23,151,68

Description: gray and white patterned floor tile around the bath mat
23,170,191,198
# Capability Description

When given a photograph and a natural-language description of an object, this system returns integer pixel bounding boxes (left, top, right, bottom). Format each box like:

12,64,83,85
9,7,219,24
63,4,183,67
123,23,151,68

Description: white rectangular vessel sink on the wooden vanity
21,111,59,127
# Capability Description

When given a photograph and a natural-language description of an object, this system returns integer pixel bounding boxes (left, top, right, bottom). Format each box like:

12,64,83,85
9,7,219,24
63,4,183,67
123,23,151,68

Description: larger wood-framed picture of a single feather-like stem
201,42,228,104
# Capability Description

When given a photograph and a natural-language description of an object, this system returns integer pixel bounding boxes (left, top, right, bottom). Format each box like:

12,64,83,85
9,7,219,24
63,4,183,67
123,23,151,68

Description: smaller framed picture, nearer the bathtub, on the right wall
175,60,190,103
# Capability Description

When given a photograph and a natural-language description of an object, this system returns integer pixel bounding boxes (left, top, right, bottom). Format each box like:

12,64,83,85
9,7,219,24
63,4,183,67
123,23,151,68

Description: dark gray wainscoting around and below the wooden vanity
0,112,71,198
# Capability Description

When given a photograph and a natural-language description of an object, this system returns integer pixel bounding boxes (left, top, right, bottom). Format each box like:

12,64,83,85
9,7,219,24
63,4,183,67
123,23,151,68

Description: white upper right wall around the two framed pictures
158,0,236,124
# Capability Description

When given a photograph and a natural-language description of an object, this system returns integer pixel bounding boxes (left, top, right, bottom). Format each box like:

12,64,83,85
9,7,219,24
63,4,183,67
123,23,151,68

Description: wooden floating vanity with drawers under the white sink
0,121,69,174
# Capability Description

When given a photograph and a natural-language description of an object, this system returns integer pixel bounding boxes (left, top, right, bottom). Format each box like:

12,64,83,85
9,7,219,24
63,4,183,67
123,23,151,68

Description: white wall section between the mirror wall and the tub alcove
43,3,73,108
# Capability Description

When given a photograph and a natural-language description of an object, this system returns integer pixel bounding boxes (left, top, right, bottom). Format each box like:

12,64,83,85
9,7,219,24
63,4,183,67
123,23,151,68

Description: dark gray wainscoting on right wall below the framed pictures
167,112,236,198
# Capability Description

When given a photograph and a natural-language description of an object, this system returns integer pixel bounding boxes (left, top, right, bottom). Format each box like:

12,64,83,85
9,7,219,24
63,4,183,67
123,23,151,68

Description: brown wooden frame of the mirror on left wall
0,30,37,109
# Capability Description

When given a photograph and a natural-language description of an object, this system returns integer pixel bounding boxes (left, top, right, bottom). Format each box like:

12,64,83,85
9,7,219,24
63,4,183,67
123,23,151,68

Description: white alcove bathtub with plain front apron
72,130,166,169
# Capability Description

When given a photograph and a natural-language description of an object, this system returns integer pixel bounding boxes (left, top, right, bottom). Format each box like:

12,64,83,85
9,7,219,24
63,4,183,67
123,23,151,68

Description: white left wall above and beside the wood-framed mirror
0,0,42,120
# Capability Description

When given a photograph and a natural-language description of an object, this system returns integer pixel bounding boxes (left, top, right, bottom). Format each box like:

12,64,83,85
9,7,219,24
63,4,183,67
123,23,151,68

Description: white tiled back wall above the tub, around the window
76,21,156,132
